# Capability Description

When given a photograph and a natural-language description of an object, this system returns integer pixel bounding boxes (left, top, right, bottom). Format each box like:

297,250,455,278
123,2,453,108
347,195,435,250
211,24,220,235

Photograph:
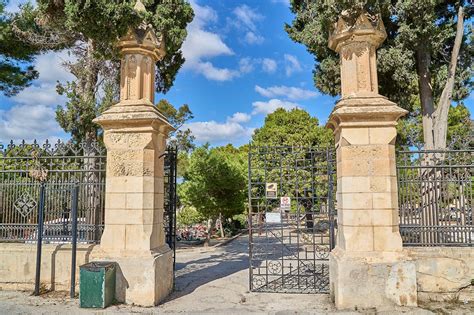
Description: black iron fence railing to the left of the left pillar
0,141,106,243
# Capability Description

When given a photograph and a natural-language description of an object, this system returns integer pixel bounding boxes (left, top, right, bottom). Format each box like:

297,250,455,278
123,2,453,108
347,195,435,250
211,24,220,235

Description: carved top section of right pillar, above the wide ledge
329,13,387,98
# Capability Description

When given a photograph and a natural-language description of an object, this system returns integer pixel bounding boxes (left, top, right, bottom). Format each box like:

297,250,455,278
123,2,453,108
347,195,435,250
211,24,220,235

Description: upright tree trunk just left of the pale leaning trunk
416,45,434,150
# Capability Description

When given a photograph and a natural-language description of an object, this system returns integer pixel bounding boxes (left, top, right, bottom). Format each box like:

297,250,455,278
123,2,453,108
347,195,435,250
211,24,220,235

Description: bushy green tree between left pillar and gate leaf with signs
178,145,247,219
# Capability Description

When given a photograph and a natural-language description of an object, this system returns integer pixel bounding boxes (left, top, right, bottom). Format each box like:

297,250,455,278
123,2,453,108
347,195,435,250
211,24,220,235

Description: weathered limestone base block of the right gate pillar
329,247,417,309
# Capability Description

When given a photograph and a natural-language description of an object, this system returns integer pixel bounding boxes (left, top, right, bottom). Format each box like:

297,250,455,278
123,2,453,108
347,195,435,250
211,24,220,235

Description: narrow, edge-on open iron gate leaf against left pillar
163,147,178,265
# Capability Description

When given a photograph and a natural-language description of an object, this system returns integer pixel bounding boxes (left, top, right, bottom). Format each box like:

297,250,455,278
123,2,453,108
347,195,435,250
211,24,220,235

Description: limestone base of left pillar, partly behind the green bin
91,245,174,306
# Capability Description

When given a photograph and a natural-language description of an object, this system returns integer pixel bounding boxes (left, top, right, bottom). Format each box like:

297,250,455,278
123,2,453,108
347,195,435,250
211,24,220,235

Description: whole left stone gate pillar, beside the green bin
92,2,173,306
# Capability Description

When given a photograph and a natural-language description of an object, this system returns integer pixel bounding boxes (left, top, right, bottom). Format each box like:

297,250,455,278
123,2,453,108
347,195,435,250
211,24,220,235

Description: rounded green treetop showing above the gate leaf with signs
251,108,333,147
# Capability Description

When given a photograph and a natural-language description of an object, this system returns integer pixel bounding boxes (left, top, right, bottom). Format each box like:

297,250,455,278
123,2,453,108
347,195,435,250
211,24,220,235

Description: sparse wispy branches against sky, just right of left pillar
156,99,195,153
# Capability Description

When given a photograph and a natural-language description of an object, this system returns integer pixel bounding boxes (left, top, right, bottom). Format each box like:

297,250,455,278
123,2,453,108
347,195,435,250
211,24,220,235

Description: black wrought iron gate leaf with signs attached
248,147,336,293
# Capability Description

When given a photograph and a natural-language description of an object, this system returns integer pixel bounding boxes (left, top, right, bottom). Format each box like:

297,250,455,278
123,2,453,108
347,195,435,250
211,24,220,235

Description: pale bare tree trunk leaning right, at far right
433,6,464,150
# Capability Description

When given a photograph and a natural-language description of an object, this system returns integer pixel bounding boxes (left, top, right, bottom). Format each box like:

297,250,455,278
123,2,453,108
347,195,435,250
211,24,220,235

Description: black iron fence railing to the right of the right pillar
397,144,474,246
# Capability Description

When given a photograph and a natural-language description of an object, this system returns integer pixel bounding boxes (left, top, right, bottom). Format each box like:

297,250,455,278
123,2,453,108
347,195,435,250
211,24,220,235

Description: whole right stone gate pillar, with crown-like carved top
328,13,417,308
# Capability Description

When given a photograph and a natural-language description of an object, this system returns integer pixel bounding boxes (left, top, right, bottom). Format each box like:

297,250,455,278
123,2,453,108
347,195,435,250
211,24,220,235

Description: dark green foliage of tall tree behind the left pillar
12,0,193,140
